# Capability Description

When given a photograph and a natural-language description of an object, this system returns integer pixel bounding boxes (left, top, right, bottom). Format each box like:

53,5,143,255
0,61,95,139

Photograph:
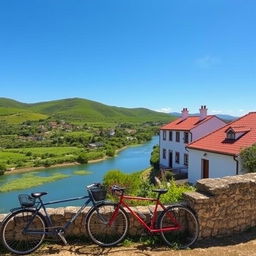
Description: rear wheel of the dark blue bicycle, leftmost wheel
1,209,46,254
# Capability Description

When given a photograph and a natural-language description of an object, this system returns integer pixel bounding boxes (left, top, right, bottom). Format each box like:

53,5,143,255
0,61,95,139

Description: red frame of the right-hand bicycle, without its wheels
109,193,181,233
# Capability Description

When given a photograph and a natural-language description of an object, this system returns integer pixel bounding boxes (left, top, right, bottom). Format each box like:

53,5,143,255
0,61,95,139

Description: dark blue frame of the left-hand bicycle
24,195,96,234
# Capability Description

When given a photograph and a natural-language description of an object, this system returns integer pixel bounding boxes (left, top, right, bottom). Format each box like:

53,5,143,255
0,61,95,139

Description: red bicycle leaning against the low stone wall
86,185,199,249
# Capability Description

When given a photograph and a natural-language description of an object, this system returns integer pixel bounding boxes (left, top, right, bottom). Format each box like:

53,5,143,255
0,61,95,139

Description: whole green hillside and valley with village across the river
0,98,176,175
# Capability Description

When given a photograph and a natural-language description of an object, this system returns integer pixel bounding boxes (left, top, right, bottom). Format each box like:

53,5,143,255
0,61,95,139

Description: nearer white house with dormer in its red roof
187,112,256,183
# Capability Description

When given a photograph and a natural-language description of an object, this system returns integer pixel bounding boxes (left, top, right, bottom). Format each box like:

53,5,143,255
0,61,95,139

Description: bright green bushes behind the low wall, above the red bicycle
103,168,194,205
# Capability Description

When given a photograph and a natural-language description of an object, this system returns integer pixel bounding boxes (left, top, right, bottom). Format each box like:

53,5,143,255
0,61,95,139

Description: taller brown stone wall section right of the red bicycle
185,173,256,238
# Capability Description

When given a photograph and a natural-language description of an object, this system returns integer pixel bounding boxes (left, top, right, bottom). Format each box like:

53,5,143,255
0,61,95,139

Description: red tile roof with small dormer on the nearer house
188,112,256,155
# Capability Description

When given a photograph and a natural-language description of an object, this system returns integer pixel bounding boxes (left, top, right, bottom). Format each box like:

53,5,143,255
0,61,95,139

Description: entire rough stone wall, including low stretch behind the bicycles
0,174,256,238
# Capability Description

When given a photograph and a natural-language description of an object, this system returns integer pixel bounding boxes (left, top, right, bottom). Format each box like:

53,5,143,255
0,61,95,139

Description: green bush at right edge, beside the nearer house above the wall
240,144,256,172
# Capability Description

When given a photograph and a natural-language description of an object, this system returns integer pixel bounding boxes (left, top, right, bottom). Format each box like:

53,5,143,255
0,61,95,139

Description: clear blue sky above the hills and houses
0,0,256,115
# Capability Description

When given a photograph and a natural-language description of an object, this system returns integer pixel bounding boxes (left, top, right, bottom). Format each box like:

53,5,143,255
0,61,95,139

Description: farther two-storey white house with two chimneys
159,106,226,172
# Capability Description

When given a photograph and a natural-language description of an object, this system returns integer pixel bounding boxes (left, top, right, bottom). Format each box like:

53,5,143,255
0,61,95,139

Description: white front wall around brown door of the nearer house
188,149,241,183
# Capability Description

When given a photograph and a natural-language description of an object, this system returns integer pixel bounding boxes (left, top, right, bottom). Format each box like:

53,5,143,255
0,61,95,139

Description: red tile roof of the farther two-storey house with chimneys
161,115,214,131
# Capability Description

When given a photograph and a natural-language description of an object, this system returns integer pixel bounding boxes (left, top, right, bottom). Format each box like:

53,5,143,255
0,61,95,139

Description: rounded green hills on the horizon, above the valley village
0,98,175,123
